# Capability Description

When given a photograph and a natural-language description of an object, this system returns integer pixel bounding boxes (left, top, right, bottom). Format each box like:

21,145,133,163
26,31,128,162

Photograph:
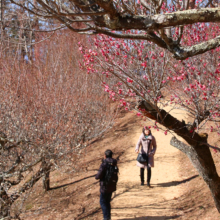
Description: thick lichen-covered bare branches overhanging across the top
6,0,220,60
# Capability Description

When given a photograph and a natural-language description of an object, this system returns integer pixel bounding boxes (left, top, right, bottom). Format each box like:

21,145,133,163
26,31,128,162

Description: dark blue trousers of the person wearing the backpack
100,193,112,220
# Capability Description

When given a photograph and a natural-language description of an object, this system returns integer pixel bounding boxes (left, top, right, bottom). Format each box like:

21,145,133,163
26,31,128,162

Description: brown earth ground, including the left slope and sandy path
17,108,220,220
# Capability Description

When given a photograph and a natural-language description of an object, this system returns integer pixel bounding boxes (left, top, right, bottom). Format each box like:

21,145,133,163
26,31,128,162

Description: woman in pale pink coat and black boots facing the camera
135,127,157,187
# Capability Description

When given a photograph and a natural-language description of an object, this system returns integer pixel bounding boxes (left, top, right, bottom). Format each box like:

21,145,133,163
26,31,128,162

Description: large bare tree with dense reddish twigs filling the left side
0,31,115,218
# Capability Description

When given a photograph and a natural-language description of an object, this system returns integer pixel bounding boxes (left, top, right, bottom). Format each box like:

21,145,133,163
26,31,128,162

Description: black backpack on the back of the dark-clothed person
104,162,119,191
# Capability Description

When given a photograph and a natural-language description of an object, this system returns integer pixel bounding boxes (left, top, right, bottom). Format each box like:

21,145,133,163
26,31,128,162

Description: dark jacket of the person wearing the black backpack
95,158,117,193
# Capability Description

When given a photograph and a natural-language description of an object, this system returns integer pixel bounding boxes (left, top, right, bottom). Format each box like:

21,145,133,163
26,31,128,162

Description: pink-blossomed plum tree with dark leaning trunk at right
79,23,220,212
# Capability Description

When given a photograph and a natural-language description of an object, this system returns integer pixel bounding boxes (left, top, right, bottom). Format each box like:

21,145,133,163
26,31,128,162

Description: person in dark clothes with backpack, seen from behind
95,150,119,220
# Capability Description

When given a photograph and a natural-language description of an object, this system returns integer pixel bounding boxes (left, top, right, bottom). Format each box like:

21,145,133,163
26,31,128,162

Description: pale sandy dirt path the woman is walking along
112,108,188,220
